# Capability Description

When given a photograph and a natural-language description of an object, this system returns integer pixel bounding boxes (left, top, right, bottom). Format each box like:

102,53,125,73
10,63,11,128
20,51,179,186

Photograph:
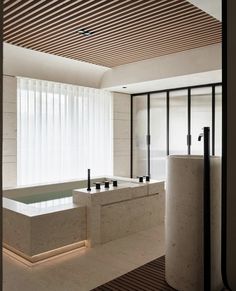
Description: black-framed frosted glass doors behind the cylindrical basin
130,83,222,179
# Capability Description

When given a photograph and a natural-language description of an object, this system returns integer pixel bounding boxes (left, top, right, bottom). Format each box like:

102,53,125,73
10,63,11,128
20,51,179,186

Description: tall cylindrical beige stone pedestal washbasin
165,156,223,291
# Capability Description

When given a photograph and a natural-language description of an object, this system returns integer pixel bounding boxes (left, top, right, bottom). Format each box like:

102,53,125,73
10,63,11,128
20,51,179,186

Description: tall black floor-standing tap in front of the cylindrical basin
198,127,211,291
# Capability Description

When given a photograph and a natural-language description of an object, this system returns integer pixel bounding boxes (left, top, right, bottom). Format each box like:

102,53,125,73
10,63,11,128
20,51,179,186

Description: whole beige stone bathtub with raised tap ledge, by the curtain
3,176,165,263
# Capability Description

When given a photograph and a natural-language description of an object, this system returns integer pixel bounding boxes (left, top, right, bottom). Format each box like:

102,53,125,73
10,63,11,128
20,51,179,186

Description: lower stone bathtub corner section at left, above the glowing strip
3,198,86,261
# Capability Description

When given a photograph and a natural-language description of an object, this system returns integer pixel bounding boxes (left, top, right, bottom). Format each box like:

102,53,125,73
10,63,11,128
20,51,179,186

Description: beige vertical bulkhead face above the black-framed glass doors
101,44,222,90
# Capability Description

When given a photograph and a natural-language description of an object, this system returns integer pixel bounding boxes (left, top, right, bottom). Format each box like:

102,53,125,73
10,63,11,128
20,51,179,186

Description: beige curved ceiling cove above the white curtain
3,43,109,88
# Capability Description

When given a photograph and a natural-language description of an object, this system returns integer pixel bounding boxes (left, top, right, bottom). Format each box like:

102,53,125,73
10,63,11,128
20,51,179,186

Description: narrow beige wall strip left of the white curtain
3,76,17,188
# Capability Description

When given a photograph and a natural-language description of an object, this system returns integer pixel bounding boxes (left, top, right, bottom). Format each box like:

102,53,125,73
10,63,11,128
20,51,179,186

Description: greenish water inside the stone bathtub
14,190,72,204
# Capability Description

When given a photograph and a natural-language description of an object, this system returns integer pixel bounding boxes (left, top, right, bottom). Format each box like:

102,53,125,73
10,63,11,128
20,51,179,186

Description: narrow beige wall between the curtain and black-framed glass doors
113,93,130,177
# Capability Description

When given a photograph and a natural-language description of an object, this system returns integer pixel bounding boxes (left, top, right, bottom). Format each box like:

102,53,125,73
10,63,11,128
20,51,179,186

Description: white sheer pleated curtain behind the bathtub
17,78,113,185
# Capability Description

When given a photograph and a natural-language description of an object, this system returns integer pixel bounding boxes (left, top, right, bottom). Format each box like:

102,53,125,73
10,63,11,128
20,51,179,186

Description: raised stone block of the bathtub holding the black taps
73,179,165,247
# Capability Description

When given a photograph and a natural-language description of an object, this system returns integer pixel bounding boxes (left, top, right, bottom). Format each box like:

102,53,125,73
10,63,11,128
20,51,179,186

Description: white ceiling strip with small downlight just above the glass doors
106,70,222,94
